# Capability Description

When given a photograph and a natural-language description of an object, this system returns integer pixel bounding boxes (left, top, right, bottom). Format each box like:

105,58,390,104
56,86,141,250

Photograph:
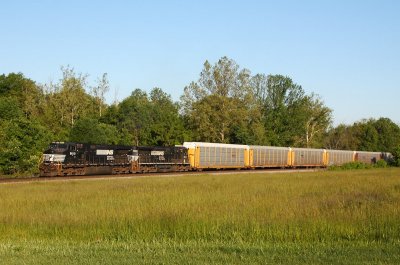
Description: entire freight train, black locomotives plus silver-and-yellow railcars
39,142,391,176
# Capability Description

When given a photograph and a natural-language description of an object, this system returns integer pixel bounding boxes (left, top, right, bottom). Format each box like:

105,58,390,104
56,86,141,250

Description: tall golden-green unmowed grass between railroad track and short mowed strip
0,168,400,244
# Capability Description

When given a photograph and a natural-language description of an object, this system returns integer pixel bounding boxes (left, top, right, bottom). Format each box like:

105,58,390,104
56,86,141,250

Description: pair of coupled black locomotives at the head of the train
40,142,190,176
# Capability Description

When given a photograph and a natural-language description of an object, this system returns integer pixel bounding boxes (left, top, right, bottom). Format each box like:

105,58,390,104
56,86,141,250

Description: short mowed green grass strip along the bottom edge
0,240,400,265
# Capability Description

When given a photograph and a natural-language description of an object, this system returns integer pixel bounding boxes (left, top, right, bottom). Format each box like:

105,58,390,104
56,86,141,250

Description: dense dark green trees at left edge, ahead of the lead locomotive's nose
0,73,51,174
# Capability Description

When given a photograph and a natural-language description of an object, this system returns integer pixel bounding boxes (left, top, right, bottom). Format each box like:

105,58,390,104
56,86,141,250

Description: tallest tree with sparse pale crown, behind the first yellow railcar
181,57,266,144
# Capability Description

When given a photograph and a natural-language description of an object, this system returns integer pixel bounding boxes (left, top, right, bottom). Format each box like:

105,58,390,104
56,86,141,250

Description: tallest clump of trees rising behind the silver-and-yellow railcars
181,57,332,147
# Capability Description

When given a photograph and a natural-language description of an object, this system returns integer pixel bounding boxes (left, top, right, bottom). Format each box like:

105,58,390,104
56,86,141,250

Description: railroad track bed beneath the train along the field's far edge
0,168,325,184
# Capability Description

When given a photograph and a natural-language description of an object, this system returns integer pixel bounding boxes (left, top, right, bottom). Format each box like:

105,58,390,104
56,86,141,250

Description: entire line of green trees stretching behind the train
0,57,400,174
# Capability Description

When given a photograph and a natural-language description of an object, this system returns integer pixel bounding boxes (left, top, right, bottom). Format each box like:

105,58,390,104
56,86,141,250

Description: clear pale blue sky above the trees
0,0,400,124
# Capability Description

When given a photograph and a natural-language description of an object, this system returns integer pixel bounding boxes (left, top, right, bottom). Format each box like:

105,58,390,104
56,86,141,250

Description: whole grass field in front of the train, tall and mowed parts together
0,168,400,264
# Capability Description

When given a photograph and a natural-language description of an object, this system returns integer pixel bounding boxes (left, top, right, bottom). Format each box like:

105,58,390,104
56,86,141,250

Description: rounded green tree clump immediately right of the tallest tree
263,75,332,148
